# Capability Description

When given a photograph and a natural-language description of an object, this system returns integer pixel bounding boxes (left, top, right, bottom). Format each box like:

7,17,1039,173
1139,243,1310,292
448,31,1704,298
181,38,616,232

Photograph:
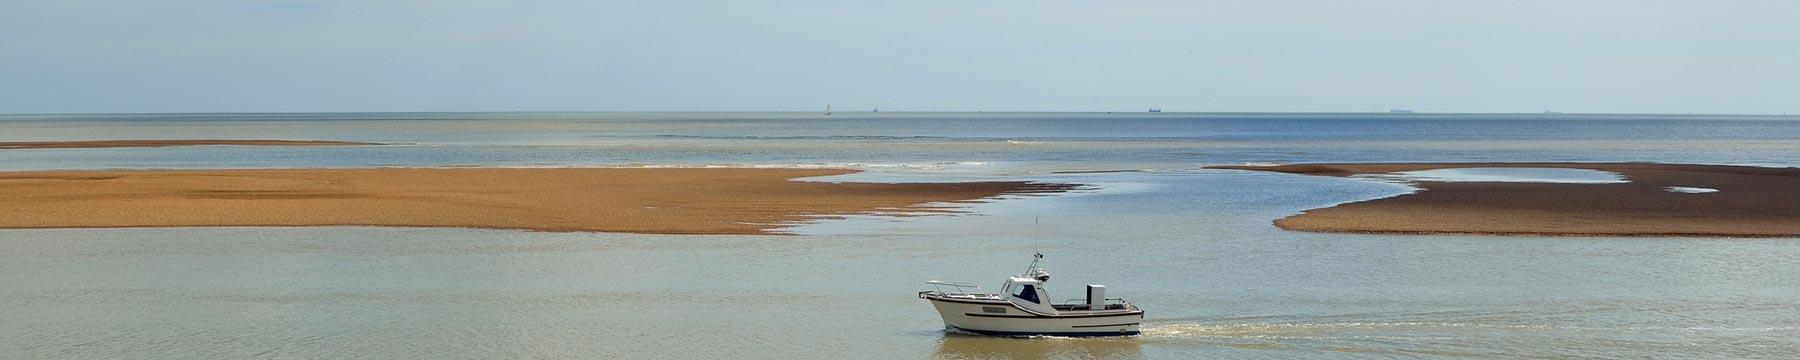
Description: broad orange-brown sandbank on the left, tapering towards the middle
0,167,1075,234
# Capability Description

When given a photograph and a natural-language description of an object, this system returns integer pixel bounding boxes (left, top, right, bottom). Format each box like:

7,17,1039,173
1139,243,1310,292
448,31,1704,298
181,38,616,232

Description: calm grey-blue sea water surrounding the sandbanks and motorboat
0,113,1800,358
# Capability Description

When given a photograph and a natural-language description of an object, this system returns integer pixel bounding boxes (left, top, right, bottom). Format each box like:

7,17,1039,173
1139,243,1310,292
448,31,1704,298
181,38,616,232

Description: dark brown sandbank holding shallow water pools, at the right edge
1215,162,1800,238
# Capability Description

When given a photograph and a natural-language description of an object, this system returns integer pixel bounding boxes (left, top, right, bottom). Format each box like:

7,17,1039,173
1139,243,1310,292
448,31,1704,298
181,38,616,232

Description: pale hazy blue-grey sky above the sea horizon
0,0,1800,113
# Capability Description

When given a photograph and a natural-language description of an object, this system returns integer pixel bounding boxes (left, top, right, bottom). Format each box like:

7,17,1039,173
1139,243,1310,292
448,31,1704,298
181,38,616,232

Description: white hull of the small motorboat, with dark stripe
920,295,1143,337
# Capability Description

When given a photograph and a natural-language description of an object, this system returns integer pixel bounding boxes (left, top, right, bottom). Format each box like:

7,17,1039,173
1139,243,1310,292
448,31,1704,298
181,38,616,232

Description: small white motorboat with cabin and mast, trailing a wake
918,254,1143,337
